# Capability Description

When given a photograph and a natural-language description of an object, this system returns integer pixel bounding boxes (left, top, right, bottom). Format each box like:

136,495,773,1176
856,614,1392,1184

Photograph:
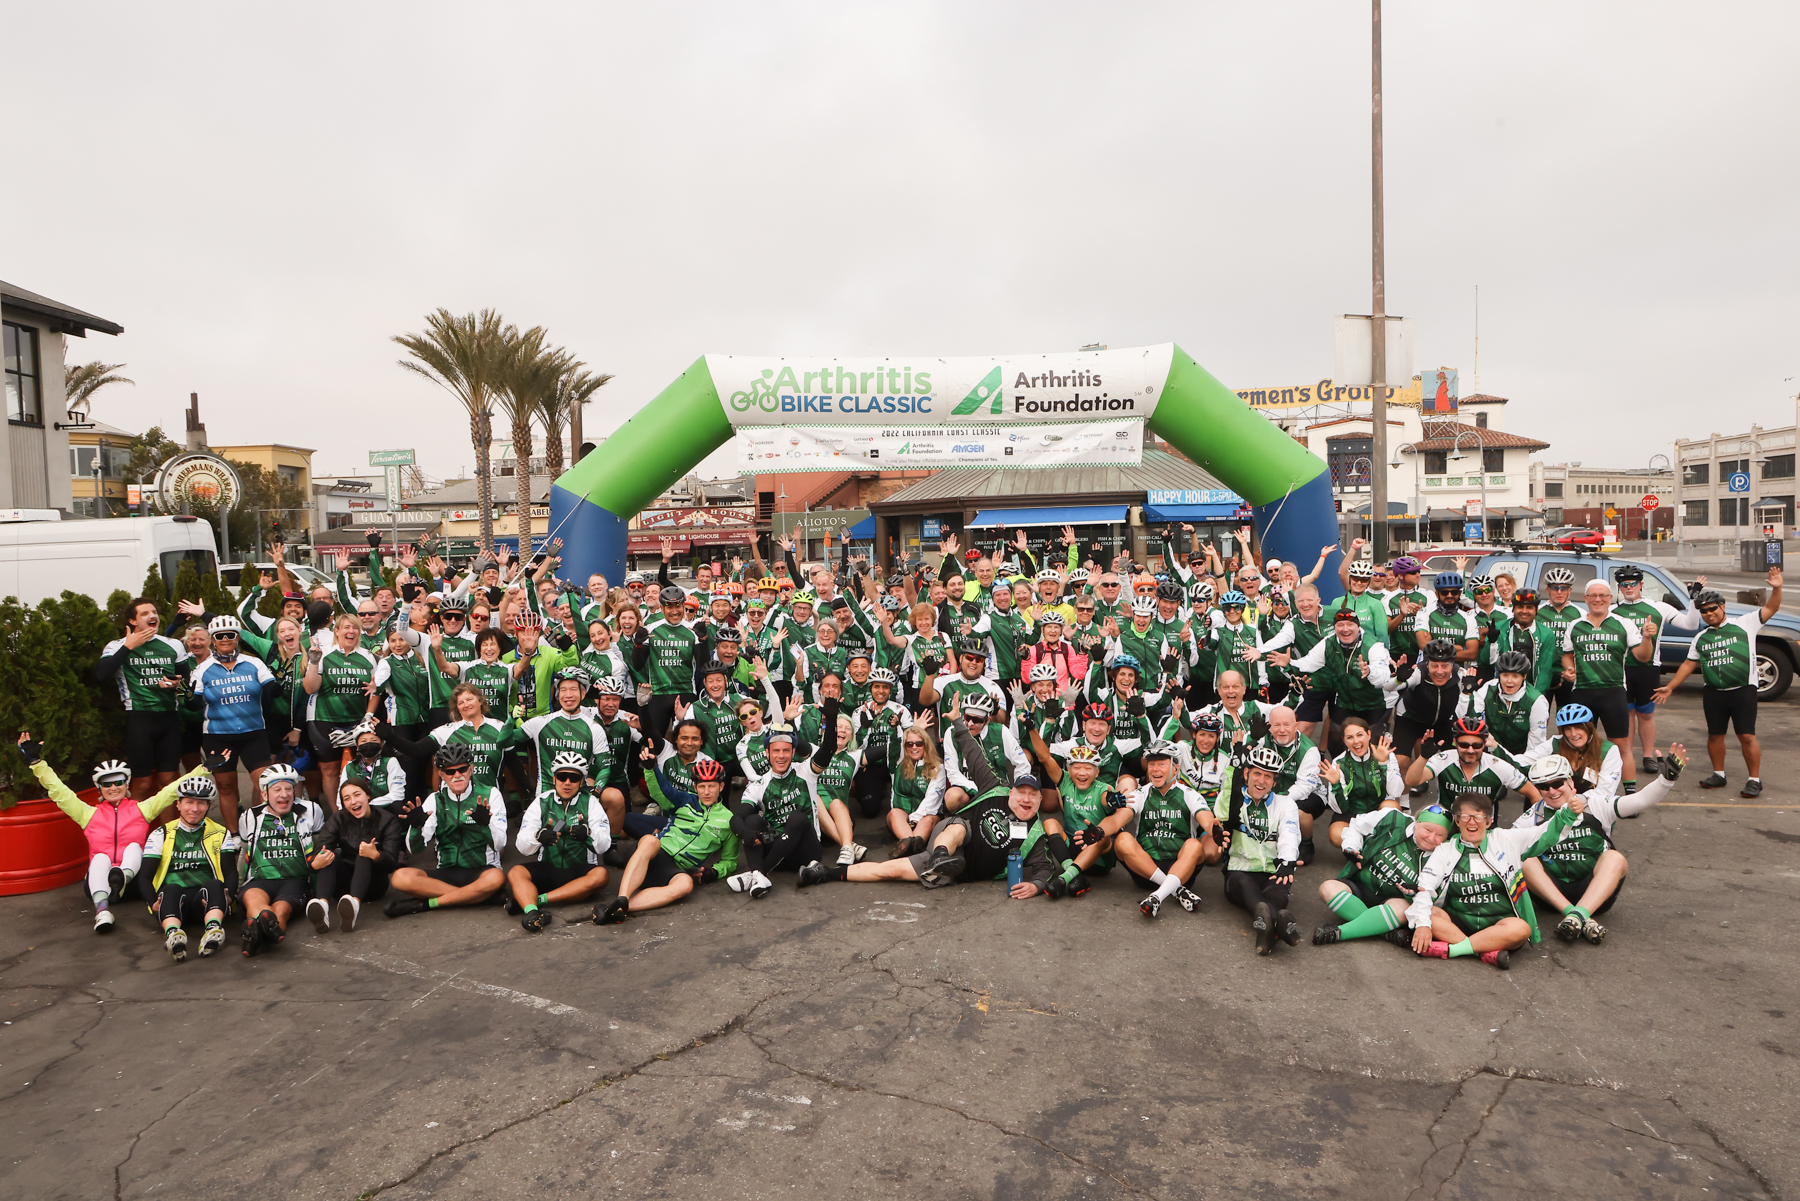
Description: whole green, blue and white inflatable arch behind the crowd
551,342,1339,598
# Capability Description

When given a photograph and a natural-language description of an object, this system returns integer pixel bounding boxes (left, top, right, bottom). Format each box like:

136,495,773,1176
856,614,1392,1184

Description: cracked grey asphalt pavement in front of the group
0,688,1800,1201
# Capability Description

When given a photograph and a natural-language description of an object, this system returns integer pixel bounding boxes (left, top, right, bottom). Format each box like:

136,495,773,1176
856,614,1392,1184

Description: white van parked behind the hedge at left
0,510,220,607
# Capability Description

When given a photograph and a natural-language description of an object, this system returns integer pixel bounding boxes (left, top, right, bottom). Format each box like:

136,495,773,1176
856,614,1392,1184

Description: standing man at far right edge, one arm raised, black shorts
1656,567,1782,796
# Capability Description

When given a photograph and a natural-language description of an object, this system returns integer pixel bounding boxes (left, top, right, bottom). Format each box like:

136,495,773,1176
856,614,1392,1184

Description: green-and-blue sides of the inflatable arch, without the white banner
551,346,1339,596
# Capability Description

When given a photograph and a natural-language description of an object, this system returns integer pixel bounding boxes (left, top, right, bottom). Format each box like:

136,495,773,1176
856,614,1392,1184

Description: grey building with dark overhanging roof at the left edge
0,283,124,517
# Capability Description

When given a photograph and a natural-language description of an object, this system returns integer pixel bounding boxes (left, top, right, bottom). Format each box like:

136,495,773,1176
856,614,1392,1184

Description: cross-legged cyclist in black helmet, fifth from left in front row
387,741,506,918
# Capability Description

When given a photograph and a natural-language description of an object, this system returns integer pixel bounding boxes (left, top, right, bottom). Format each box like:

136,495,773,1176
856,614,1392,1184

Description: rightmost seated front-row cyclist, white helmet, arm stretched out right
1514,742,1687,945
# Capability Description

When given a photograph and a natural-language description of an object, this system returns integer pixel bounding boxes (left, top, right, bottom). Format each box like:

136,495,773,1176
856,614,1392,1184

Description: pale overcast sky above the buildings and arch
14,0,1800,475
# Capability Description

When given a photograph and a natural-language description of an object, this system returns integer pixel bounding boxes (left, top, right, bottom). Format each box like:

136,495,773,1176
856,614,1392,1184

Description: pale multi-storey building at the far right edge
1674,417,1795,542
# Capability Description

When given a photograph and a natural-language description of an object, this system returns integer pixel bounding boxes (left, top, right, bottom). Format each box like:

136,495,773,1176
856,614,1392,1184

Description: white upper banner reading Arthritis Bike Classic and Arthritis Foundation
706,342,1174,429
